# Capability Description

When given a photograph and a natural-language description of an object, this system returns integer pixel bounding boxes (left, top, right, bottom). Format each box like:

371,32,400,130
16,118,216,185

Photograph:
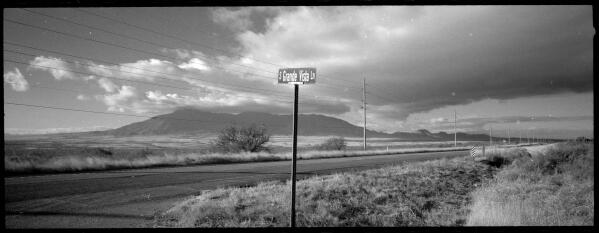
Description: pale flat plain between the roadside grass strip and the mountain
4,134,487,152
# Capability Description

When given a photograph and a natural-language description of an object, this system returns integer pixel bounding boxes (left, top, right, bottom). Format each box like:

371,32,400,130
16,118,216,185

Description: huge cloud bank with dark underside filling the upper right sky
223,6,594,119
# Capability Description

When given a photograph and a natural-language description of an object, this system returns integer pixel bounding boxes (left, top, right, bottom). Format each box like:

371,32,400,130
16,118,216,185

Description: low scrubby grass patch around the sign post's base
156,158,495,227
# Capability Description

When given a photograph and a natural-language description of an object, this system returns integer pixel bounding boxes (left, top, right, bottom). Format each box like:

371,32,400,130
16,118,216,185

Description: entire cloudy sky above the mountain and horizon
3,5,595,138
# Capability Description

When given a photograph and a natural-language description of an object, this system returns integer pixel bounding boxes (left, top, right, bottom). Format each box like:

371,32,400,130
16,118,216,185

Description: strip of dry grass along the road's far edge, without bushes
4,147,467,174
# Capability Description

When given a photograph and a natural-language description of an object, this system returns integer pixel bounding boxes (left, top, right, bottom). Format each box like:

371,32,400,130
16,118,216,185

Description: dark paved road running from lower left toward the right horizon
4,151,469,228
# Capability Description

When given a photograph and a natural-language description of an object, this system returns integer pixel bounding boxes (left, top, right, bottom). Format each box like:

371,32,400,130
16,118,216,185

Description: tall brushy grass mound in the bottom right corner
468,143,594,226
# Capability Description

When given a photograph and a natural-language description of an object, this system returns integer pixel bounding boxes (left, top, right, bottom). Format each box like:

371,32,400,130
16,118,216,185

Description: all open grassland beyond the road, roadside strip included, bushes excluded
4,134,492,174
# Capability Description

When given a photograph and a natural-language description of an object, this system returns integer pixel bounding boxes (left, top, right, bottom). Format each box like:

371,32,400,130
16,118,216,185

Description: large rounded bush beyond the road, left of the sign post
212,125,270,153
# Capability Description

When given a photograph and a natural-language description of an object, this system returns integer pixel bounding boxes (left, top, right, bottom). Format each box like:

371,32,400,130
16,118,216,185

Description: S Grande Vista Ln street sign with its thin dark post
278,68,316,227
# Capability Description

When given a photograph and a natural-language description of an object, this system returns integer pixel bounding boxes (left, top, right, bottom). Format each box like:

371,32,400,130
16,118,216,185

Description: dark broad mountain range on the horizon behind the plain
94,108,489,141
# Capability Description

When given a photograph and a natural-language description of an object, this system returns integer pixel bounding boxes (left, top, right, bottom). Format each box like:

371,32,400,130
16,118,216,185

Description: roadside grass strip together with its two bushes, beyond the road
4,125,478,174
